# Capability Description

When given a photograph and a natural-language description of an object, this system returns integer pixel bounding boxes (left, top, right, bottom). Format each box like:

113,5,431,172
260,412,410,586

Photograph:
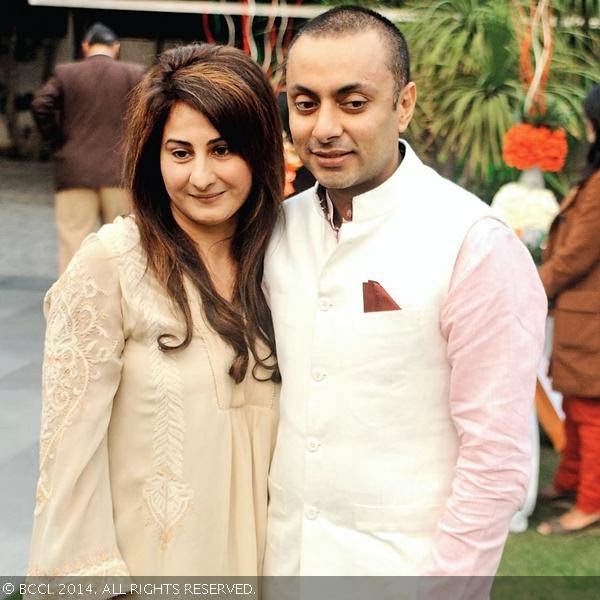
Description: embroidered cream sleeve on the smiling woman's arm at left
29,235,128,575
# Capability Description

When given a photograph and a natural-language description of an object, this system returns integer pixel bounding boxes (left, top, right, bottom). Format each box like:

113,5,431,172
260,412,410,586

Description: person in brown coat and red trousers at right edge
538,85,600,535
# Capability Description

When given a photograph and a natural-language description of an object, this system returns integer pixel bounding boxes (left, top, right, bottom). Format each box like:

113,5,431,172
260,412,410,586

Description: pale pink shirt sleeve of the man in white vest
425,218,547,575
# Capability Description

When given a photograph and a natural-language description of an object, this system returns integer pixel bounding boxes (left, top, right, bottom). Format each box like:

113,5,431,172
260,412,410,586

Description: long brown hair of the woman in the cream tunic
124,44,284,383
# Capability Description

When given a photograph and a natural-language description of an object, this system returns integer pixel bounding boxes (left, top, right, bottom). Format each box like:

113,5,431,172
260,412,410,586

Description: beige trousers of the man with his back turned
54,187,130,273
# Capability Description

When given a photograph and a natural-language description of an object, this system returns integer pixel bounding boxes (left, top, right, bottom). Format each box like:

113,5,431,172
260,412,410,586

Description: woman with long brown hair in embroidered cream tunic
30,45,284,576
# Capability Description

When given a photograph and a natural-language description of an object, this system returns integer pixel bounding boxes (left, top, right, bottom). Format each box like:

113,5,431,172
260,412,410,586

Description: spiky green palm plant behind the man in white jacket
403,0,597,190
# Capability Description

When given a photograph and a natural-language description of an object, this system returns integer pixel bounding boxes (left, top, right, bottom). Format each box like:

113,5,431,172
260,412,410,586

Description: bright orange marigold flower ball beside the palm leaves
502,123,568,173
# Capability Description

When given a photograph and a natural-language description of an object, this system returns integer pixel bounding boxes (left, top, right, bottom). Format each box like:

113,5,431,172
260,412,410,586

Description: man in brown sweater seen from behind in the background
31,23,144,273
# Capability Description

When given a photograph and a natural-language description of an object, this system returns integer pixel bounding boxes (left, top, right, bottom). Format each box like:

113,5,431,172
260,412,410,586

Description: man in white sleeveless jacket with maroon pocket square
264,7,546,575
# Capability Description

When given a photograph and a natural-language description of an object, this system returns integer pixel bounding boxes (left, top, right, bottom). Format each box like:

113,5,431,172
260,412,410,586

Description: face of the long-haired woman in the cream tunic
160,102,252,239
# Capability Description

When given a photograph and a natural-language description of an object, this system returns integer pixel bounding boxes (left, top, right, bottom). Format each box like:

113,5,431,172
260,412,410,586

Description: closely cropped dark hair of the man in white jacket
289,6,410,104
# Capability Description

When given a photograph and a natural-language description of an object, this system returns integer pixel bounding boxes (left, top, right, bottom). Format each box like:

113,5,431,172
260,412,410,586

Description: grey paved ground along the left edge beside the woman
0,159,58,575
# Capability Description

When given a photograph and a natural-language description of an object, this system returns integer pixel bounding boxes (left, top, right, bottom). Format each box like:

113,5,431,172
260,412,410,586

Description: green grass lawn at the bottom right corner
498,446,600,576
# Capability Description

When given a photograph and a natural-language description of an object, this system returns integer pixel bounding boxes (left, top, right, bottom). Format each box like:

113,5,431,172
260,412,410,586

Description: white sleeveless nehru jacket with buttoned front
264,143,489,575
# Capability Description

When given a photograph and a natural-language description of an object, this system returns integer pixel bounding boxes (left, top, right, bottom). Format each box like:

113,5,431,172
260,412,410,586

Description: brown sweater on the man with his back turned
31,54,144,190
